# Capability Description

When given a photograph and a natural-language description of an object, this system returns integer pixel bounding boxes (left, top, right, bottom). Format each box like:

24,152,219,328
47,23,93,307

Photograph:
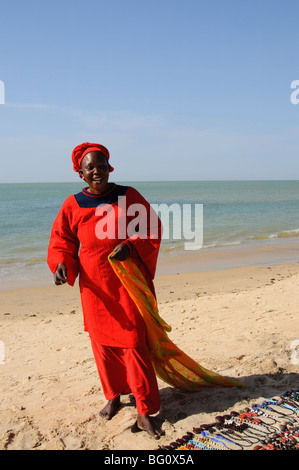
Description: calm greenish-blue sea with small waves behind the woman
0,181,299,288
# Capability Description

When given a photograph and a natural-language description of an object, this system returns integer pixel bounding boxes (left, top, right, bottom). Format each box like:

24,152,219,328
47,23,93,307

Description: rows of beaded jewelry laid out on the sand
159,390,299,451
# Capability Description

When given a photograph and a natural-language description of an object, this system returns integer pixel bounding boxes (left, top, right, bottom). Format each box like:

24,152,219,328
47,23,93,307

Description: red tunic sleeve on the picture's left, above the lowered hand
47,196,80,286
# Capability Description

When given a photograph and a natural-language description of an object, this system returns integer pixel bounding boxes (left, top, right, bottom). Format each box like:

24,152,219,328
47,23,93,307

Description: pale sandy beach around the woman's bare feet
0,252,299,450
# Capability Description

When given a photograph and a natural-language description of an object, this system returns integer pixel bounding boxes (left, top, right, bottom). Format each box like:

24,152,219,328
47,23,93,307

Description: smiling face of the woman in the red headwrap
79,152,109,193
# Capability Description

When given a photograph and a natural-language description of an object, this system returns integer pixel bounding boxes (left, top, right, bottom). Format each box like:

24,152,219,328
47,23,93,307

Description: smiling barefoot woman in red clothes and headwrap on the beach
48,142,161,438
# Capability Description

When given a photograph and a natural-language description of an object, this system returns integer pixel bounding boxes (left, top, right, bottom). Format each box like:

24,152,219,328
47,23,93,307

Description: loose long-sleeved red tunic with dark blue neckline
48,184,161,348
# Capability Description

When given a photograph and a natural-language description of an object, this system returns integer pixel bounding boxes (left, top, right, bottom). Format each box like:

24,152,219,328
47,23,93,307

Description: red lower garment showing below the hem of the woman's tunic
91,340,160,415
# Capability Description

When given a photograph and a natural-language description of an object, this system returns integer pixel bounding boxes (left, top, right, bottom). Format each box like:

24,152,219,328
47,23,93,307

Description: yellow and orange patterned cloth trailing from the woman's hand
108,253,244,392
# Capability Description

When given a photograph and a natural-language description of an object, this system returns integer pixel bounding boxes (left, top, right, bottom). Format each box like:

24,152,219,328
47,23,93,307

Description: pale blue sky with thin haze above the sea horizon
0,0,299,183
